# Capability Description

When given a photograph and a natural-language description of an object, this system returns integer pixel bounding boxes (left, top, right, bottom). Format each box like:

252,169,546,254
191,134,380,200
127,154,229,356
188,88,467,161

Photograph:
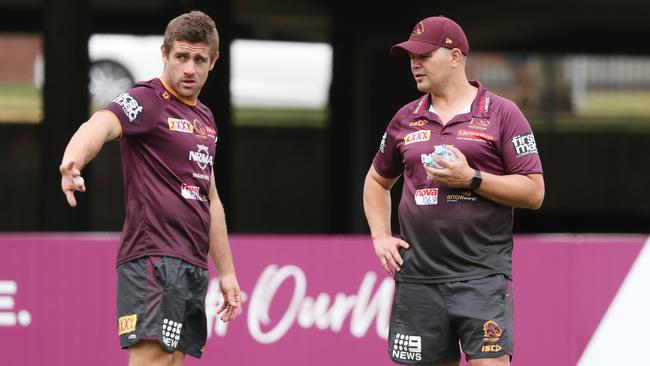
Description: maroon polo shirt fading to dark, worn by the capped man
373,81,542,283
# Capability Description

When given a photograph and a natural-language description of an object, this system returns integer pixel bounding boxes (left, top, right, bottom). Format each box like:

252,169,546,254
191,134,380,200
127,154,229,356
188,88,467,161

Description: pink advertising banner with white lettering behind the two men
0,234,647,366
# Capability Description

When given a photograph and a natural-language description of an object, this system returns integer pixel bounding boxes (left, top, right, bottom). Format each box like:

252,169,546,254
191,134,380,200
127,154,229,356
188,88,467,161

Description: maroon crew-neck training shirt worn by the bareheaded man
105,79,217,268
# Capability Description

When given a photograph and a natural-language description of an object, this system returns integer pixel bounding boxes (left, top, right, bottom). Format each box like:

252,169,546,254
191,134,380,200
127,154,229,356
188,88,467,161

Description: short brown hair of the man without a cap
163,10,219,53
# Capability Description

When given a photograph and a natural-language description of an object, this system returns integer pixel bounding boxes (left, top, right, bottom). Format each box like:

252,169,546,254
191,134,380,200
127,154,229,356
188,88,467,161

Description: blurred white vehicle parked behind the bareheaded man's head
34,34,332,109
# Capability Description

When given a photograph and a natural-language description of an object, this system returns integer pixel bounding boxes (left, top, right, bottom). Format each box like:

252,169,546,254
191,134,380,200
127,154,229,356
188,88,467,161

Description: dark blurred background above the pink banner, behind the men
0,0,650,233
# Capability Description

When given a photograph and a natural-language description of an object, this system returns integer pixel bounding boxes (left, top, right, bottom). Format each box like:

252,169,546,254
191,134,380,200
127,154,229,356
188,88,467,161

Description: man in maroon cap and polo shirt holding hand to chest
364,16,544,366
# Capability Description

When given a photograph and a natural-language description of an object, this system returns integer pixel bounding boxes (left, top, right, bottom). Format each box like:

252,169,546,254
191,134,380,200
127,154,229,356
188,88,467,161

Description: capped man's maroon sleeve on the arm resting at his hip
372,116,404,178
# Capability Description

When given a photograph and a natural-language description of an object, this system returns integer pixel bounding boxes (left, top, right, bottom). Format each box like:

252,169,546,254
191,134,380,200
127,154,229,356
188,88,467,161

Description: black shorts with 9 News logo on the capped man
388,275,514,365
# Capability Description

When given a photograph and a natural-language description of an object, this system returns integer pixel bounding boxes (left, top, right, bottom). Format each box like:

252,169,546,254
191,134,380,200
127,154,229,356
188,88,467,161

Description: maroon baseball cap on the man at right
390,15,469,55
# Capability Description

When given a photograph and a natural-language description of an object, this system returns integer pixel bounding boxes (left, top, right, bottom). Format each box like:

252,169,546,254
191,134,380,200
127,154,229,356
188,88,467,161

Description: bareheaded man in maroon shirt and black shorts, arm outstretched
60,11,241,365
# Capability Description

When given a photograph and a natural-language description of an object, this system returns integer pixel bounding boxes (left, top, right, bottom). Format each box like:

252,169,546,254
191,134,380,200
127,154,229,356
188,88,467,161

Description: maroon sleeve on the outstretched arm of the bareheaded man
104,86,163,136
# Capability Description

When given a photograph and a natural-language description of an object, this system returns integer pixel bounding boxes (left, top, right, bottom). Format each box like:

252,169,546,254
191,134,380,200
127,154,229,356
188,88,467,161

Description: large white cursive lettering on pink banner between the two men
205,265,395,344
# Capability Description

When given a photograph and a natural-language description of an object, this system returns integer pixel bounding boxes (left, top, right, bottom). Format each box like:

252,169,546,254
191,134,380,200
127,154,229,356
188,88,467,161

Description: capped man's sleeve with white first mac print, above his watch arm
501,101,543,174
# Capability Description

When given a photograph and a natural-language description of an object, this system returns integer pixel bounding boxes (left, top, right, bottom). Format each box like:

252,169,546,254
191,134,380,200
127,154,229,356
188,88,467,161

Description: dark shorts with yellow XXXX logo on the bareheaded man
117,257,209,358
